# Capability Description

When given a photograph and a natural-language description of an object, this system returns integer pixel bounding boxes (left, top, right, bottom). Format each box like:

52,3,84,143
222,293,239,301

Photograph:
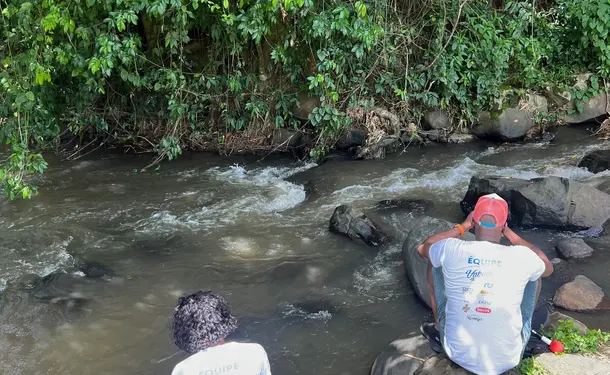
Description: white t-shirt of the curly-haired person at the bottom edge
172,342,271,375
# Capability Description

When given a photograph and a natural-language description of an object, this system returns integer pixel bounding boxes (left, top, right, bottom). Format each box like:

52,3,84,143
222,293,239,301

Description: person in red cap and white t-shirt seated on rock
418,194,553,375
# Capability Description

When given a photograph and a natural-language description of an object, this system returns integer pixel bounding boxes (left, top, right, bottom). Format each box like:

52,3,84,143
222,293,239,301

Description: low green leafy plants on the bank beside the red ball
550,320,610,353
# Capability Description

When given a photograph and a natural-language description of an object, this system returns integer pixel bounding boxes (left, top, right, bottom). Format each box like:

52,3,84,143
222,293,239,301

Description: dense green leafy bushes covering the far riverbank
0,0,610,198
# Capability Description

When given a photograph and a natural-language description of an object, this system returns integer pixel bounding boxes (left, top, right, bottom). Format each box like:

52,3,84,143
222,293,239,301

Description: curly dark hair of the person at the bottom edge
172,291,237,354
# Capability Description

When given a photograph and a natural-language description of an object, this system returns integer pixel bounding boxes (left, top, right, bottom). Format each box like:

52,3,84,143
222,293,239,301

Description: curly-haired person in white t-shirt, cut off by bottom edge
167,291,271,375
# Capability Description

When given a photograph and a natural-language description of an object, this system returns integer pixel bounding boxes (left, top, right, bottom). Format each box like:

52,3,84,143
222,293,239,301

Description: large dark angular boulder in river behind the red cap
460,176,610,230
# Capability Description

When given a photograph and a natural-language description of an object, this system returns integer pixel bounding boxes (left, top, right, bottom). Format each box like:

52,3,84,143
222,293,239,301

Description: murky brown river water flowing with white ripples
0,125,610,375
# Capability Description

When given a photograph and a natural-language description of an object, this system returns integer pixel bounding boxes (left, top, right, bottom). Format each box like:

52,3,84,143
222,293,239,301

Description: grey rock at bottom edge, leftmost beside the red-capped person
371,335,435,375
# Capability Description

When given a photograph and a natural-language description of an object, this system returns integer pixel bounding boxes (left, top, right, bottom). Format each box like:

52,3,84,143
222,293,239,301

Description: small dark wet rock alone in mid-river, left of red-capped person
330,205,389,246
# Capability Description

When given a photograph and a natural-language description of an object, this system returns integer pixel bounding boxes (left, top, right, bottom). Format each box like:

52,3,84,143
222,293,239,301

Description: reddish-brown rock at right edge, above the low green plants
553,275,610,311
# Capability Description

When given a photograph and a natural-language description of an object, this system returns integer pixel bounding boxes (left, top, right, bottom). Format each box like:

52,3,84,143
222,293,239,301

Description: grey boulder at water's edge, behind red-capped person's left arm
402,216,474,307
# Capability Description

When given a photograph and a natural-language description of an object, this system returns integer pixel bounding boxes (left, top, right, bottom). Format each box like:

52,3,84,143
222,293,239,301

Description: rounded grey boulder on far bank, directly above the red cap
472,94,548,141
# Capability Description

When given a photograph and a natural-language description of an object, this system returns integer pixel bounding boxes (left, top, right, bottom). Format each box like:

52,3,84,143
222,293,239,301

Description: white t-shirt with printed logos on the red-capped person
430,238,545,375
